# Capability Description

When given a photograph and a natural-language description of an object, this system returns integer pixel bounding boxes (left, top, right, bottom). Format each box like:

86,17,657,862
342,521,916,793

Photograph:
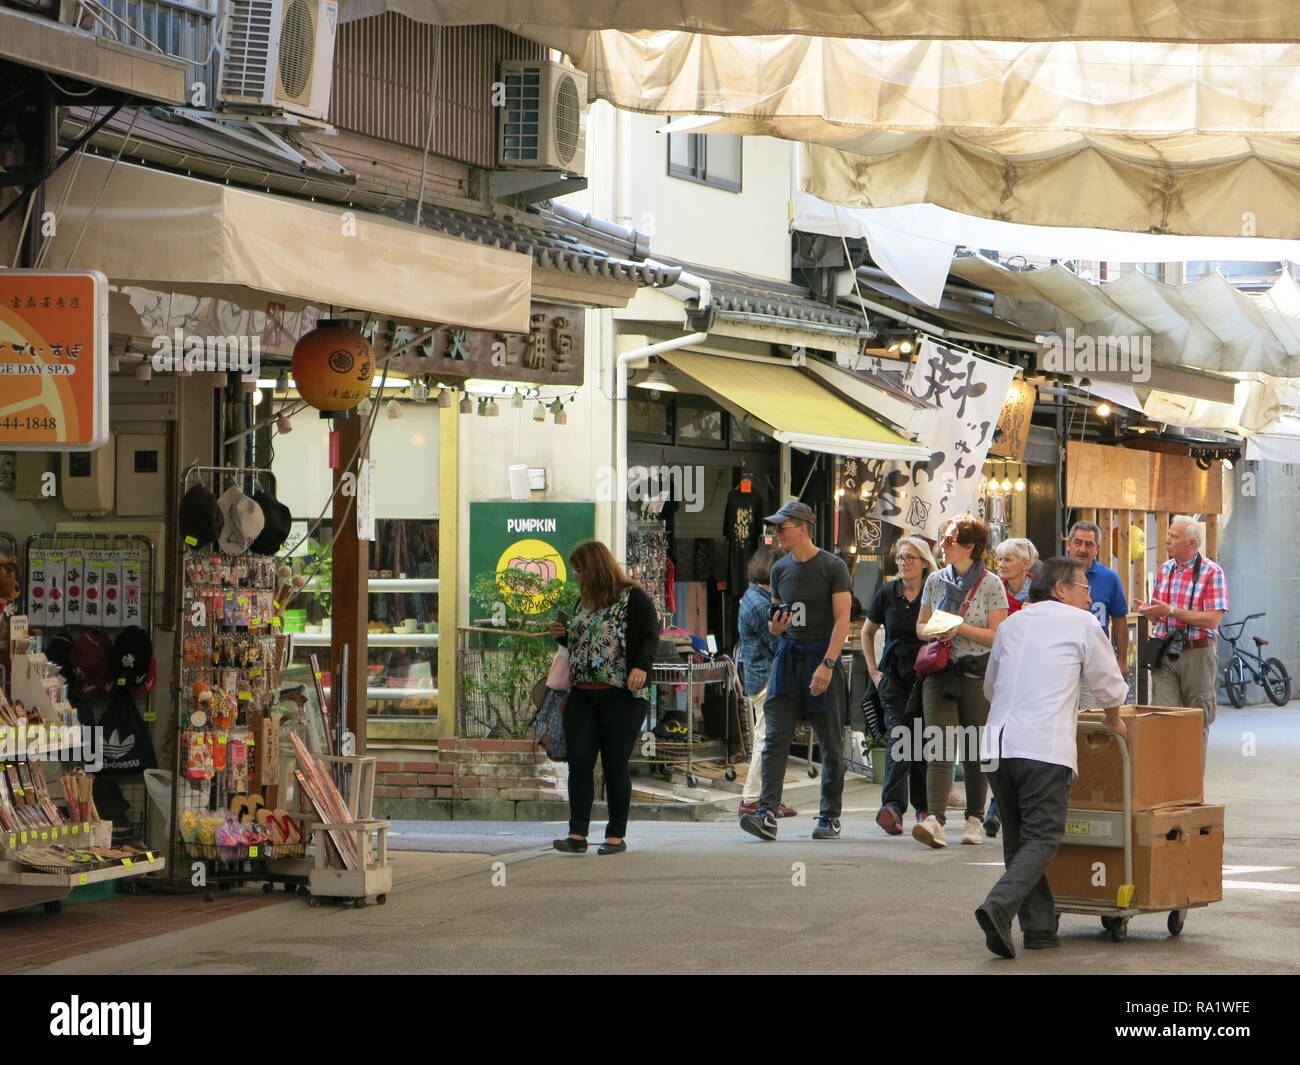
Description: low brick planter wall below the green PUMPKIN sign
374,740,558,800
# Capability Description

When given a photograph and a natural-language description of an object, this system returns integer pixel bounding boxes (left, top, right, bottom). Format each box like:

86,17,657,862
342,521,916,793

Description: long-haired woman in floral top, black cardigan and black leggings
550,540,660,854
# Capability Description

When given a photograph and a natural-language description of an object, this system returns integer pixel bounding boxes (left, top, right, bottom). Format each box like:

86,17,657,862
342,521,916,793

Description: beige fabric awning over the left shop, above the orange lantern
44,156,533,333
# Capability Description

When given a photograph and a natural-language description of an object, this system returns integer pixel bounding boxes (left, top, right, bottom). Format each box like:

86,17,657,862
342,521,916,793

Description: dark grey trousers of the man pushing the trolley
984,758,1070,932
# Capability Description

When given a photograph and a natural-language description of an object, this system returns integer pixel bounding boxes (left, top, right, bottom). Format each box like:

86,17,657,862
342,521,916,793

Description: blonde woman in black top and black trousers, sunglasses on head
862,536,936,836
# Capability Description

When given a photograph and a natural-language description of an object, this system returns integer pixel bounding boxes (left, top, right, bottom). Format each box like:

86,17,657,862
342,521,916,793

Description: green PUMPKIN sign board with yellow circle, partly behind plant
469,502,595,622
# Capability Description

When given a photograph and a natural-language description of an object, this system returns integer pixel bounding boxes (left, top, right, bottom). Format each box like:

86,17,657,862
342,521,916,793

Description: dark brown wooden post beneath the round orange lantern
329,411,371,756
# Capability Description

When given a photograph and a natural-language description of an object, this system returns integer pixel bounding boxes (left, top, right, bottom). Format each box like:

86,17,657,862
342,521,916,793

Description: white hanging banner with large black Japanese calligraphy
867,339,1015,540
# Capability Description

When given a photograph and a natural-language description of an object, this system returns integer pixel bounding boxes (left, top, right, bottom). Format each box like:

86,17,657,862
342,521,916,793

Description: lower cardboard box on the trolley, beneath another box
1047,805,1223,910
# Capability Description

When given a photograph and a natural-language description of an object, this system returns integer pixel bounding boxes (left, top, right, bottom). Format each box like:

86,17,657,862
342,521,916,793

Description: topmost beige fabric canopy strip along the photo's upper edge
341,0,1300,40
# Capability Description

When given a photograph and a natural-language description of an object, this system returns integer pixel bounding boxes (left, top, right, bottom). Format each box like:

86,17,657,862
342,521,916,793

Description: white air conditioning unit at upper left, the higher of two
217,0,338,118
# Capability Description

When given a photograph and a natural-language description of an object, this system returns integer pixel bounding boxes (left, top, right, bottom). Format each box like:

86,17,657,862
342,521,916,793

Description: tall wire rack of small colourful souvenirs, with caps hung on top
170,466,307,900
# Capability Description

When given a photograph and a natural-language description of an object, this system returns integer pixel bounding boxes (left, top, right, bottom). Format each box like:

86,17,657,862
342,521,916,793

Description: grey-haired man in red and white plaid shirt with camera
1136,515,1227,759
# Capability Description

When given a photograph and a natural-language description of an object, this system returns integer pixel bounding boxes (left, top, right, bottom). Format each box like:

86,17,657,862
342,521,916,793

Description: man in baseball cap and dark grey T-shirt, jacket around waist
740,501,853,840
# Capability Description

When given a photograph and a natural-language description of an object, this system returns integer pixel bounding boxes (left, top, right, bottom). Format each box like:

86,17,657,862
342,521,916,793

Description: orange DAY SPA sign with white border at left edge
0,270,108,451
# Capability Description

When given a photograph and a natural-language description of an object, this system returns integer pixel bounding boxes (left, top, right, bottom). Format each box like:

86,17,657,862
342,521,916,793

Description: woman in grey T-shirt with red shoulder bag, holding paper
911,514,1008,848
